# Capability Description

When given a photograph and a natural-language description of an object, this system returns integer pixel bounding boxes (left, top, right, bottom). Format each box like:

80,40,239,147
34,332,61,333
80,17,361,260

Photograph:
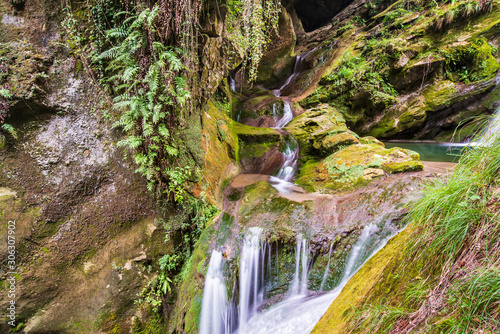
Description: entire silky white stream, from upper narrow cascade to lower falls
200,49,406,334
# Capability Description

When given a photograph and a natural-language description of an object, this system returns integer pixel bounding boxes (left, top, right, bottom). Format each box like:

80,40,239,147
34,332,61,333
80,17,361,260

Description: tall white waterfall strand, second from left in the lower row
239,227,263,330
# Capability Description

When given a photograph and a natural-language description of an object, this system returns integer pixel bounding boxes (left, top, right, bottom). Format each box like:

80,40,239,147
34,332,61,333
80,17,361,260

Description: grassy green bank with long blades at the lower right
353,117,500,333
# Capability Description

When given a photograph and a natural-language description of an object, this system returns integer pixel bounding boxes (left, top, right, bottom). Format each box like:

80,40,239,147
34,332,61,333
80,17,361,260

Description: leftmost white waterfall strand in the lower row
200,250,230,334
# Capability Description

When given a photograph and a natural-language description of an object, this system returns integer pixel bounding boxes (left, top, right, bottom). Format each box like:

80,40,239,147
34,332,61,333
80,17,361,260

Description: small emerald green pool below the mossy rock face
384,142,467,162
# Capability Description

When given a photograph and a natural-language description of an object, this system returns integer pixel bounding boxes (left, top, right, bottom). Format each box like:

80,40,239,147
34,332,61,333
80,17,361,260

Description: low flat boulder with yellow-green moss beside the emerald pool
297,144,423,192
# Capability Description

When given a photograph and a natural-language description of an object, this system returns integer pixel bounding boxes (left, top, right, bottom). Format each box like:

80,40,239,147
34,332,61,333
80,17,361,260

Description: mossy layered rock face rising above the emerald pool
300,2,500,140
